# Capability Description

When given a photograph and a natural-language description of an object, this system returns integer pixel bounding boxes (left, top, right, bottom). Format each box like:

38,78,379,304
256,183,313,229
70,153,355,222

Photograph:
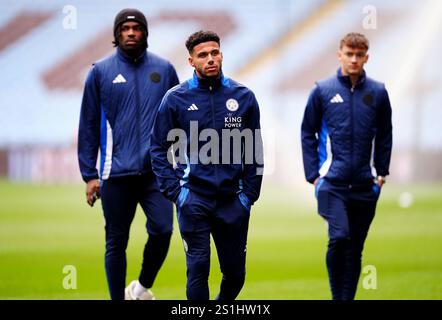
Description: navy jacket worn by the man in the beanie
78,48,179,182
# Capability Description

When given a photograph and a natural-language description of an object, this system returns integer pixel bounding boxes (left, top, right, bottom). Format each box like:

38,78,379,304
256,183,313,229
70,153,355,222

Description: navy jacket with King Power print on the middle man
151,73,263,204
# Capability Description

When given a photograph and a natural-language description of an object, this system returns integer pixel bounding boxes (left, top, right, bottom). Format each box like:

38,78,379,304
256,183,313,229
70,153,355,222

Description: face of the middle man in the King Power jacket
189,41,223,78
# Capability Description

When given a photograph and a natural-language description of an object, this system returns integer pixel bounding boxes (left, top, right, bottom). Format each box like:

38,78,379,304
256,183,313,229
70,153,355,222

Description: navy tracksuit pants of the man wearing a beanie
100,174,173,300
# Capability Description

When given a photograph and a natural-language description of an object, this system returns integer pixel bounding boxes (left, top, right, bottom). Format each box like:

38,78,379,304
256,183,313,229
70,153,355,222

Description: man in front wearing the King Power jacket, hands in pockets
151,31,263,300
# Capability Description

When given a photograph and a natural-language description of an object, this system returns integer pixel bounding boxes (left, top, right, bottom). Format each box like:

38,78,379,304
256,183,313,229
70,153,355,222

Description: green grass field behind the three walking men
0,181,442,300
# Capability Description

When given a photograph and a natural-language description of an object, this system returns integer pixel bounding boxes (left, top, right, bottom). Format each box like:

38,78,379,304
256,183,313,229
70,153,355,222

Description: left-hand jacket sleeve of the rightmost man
301,86,322,183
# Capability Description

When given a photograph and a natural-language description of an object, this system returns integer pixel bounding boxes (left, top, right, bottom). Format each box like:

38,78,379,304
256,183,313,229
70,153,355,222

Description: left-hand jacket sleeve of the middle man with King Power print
150,93,181,202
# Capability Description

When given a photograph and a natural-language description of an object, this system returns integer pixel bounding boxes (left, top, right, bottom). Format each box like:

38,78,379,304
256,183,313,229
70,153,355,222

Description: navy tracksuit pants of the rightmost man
315,178,380,300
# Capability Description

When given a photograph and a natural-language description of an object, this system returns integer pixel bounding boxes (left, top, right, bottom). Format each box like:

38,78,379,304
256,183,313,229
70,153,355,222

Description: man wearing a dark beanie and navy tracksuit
78,9,179,300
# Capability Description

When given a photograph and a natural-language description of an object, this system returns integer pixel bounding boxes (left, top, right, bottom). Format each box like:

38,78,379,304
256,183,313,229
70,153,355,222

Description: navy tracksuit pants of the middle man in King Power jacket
177,187,250,300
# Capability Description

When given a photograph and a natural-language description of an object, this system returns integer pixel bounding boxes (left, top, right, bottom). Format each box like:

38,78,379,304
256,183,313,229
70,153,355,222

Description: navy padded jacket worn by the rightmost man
301,69,392,185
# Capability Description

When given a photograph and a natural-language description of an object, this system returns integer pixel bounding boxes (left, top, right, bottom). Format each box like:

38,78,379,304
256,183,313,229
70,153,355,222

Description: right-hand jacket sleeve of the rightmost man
374,89,393,176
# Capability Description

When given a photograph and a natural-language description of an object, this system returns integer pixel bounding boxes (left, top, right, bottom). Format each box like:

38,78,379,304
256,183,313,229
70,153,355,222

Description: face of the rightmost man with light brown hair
338,46,368,76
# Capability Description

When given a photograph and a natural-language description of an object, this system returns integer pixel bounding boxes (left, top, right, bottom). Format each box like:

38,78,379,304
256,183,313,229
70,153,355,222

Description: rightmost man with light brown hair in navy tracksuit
301,33,392,300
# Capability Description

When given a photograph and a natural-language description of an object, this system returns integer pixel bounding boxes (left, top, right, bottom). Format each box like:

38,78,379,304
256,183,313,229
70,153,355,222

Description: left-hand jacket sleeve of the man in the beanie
77,67,101,182
